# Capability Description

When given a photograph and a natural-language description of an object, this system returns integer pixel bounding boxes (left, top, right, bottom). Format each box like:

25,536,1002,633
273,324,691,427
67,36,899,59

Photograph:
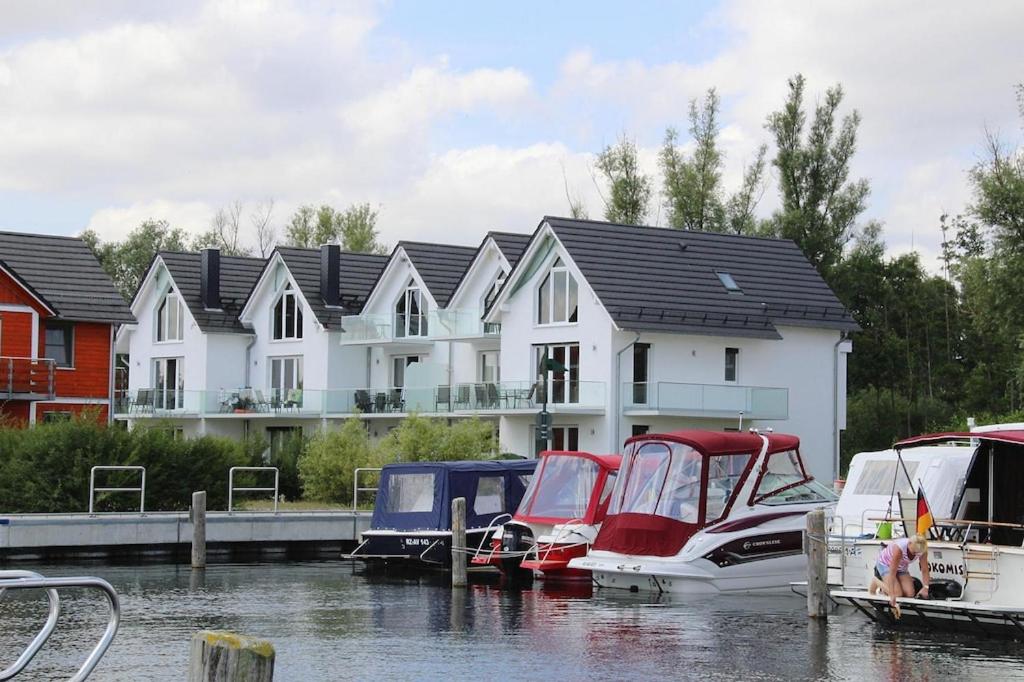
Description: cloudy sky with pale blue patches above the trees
0,0,1024,267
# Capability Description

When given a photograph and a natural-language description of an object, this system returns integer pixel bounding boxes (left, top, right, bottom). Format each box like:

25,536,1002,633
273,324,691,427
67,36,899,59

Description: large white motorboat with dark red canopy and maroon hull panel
568,431,837,593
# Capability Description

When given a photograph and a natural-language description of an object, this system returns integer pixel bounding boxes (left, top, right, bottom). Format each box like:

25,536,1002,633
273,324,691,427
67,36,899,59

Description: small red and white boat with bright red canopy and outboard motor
472,451,622,580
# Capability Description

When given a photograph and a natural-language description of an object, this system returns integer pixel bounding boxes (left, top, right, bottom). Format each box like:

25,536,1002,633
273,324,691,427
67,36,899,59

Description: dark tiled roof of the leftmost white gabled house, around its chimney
159,251,266,333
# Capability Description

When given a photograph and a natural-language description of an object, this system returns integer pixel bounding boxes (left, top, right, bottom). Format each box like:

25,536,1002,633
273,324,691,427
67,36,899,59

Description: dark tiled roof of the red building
0,232,135,324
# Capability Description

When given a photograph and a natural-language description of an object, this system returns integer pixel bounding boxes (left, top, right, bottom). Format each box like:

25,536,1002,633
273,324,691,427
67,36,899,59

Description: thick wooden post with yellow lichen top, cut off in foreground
188,630,274,682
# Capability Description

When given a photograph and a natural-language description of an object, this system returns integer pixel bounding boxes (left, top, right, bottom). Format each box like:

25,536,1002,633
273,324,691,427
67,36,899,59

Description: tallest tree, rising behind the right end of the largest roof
766,74,870,275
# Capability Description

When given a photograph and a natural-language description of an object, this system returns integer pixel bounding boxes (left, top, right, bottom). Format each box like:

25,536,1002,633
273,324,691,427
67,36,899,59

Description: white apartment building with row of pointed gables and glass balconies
116,217,856,478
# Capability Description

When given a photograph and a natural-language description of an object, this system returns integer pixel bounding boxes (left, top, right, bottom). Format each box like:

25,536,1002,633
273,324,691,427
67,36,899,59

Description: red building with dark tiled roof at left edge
0,232,134,424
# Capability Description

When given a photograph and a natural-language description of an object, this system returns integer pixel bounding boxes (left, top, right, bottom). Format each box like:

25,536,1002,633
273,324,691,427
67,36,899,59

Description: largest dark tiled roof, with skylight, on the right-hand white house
545,217,857,338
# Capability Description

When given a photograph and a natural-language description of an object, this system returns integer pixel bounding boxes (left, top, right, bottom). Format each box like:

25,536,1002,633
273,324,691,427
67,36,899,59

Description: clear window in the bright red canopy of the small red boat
519,457,600,519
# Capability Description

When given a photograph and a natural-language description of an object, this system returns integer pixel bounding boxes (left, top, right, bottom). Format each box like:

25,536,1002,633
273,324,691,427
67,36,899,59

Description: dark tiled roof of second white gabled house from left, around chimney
278,247,388,329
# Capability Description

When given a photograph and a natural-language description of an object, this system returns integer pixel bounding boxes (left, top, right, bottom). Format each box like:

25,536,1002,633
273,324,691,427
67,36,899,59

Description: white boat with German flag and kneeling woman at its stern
831,428,1024,637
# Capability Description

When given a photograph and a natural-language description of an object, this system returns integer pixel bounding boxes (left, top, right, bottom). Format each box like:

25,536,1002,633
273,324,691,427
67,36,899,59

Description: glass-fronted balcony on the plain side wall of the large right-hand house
623,381,790,419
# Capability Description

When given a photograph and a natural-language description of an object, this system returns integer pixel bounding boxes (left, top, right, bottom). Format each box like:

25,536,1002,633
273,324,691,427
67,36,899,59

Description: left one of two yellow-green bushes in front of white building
298,418,380,504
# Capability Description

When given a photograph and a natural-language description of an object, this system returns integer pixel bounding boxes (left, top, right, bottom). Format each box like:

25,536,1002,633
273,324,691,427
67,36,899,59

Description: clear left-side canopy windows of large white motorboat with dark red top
608,442,703,523
